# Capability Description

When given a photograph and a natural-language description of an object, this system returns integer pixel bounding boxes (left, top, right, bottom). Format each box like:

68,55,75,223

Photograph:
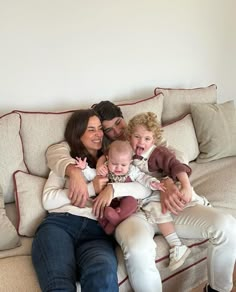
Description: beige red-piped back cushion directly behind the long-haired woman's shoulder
14,111,73,177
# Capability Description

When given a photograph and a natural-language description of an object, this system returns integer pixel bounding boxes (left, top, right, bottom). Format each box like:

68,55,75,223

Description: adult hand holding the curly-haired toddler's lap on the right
161,178,186,215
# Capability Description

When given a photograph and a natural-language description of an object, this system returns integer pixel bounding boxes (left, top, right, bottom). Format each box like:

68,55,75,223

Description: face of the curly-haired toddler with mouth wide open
130,126,154,155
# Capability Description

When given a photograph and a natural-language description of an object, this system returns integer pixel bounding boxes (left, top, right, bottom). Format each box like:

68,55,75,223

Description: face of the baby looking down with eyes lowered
107,152,131,175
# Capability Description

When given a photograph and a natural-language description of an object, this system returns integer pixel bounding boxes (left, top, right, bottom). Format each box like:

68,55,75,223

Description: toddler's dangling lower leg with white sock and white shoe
158,222,190,271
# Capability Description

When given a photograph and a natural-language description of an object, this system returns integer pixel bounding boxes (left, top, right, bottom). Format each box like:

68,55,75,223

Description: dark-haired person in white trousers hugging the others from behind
47,101,236,292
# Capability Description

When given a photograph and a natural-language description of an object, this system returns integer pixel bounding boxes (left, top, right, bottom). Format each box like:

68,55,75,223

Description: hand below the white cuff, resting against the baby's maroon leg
92,184,113,218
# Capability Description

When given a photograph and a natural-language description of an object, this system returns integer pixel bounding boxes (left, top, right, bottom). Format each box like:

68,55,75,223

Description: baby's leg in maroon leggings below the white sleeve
104,196,138,226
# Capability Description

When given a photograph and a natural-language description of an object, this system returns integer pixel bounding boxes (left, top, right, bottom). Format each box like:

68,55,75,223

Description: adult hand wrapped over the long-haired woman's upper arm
66,164,89,208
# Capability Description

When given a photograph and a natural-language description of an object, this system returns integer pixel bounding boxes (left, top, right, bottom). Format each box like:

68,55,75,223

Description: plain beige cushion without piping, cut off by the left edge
0,190,20,251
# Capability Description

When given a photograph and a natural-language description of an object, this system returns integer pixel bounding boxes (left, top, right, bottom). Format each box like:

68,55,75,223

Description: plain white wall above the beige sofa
0,0,236,113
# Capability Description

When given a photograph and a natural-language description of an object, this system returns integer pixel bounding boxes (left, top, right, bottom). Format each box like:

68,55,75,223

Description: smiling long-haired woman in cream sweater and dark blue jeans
32,109,118,292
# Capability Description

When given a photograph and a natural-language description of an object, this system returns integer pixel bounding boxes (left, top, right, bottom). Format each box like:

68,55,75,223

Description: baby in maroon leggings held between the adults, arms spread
76,140,164,234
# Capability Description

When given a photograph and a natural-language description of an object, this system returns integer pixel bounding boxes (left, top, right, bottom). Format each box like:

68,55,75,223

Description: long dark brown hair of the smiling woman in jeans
64,109,100,167
